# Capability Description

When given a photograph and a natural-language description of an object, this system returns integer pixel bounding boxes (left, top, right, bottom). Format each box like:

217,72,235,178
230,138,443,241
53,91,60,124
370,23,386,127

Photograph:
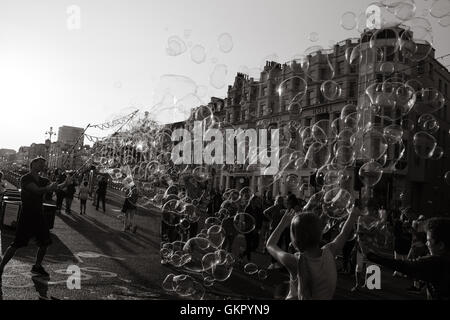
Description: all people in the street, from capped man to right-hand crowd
0,158,450,299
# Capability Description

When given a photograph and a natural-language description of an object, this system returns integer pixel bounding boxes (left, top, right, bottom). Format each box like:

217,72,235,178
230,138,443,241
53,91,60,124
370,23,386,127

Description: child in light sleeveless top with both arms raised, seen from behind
267,207,360,300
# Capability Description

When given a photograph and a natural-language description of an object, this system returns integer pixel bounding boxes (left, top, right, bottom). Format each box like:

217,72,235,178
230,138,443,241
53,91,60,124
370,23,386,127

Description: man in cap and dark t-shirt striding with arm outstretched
0,158,67,285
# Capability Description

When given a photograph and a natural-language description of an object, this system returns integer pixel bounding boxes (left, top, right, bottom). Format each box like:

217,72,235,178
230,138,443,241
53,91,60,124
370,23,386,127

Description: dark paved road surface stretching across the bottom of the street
0,181,425,300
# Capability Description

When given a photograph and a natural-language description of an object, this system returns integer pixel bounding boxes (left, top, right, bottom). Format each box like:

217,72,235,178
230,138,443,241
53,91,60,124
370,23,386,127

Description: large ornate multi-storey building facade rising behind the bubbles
176,28,450,215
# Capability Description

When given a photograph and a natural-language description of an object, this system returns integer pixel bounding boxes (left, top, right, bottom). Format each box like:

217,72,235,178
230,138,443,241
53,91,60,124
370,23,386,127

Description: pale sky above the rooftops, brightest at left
0,0,450,150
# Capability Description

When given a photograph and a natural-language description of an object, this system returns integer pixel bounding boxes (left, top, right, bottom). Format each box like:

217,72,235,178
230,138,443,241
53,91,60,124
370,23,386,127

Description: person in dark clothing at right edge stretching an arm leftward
367,218,450,300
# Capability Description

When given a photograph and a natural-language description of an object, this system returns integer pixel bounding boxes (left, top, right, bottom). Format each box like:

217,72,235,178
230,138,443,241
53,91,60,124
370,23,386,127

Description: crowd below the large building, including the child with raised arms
161,180,450,299
